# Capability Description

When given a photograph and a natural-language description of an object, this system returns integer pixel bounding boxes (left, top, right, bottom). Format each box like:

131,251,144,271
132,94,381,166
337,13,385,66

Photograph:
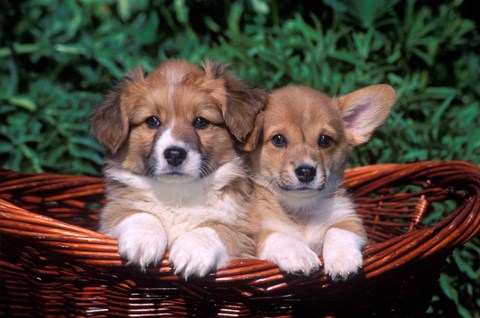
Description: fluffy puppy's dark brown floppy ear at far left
90,67,144,154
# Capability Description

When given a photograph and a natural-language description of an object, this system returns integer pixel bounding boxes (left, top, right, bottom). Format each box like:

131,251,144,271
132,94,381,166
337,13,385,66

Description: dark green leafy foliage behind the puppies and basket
0,0,480,317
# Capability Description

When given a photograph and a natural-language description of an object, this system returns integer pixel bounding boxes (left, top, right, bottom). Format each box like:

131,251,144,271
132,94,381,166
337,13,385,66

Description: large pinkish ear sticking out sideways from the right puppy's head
336,84,396,146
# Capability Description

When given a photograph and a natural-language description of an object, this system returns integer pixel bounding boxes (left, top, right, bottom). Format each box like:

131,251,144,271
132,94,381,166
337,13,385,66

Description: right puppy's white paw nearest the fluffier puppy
260,232,321,276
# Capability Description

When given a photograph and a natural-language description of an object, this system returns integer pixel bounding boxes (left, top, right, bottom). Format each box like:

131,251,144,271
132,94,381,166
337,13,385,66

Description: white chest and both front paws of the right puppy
259,197,365,279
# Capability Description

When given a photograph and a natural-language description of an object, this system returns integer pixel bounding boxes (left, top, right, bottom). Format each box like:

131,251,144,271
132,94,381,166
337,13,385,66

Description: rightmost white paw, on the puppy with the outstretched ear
323,228,366,280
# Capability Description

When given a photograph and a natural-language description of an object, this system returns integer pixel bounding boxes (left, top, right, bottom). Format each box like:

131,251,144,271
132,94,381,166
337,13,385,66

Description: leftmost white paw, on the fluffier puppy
111,213,167,270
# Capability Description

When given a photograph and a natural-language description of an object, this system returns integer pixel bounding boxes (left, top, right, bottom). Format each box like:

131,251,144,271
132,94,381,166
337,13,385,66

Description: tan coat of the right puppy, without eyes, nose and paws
250,85,395,276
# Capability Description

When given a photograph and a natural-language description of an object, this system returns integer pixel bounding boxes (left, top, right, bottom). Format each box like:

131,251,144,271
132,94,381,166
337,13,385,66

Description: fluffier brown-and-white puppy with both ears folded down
91,60,266,278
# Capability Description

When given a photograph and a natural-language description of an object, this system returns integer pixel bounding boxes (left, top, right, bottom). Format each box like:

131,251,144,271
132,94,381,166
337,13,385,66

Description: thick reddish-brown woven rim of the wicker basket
0,161,480,282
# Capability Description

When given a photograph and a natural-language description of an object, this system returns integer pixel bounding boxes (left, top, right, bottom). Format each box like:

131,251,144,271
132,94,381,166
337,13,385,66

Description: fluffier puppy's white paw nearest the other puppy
170,227,228,279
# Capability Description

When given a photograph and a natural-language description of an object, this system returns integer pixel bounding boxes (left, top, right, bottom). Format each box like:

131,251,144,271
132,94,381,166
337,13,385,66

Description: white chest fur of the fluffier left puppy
106,161,245,246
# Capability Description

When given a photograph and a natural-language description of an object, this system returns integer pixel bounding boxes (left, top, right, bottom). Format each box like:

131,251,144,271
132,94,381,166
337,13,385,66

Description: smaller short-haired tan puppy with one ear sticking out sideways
246,85,396,279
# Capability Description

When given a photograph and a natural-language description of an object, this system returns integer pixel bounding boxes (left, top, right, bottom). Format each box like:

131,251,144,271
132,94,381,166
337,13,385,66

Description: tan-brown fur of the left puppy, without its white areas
91,60,267,276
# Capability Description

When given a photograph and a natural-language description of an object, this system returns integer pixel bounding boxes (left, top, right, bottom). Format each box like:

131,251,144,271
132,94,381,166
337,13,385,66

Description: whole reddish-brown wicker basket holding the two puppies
0,161,480,317
